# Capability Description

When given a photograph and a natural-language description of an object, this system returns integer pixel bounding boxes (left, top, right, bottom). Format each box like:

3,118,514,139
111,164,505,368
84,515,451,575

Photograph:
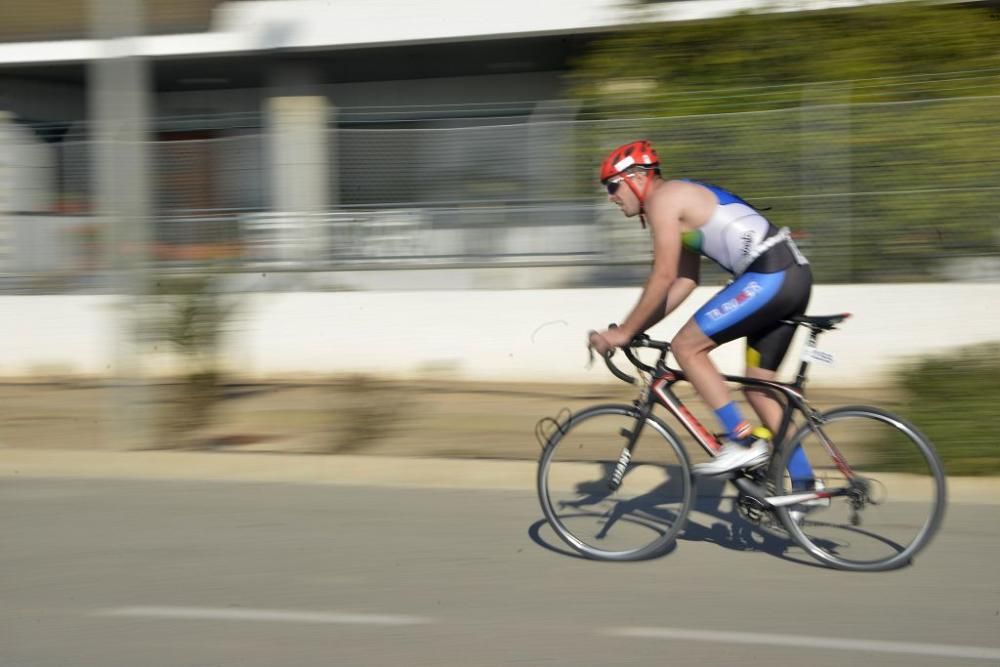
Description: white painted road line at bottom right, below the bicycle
604,628,1000,660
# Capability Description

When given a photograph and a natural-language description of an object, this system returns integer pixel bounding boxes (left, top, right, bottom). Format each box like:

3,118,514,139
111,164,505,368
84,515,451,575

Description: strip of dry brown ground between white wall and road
0,378,898,459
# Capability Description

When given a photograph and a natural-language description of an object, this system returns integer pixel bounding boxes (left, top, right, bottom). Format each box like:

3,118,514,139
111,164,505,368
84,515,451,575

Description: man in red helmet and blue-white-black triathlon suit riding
589,140,815,488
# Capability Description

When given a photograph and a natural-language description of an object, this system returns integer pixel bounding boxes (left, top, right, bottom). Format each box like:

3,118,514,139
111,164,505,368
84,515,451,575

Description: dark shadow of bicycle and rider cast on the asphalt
528,464,822,567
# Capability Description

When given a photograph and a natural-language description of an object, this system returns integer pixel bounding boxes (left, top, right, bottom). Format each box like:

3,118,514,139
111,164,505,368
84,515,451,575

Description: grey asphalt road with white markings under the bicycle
0,479,1000,667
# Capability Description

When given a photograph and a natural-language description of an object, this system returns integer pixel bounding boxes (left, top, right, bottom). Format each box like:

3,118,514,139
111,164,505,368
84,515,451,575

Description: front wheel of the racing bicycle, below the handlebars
538,405,694,561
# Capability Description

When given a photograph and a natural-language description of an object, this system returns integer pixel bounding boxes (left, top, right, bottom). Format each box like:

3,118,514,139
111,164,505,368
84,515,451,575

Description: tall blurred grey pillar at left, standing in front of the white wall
87,0,152,449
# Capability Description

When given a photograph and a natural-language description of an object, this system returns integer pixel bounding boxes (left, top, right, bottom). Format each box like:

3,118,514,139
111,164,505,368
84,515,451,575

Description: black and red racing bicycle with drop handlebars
536,313,947,571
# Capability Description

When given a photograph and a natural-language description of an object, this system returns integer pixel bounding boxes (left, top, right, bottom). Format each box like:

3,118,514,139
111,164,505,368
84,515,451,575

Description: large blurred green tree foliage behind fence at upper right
572,3,1000,281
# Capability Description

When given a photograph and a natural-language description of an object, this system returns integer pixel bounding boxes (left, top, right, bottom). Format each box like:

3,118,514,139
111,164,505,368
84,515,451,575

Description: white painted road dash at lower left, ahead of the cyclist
91,607,433,625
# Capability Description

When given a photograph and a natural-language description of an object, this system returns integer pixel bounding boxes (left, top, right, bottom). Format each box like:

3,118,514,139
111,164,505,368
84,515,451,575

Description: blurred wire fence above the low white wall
2,98,1000,291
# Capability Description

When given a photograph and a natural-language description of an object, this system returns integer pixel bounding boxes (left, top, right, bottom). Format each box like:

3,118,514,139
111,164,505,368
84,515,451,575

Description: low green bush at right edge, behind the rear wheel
897,343,1000,475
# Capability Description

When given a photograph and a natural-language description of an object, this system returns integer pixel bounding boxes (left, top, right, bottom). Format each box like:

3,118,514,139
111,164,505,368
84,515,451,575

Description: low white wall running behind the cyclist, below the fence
0,284,1000,387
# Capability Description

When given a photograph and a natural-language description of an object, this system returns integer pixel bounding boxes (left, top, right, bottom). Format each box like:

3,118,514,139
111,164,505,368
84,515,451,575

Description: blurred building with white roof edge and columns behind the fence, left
0,0,1000,286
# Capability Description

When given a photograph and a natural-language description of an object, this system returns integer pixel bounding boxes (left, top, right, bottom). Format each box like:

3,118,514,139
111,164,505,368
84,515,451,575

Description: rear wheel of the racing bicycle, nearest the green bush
773,406,946,572
